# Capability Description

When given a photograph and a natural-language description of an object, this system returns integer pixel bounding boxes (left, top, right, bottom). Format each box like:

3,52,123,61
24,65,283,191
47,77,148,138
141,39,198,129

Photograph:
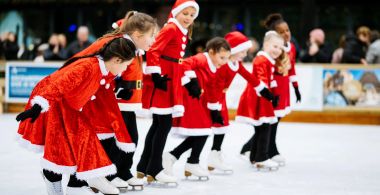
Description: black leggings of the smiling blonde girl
250,123,271,162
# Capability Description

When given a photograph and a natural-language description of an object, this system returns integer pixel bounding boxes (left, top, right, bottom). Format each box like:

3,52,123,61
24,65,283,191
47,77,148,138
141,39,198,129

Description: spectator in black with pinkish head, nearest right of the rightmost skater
300,28,332,63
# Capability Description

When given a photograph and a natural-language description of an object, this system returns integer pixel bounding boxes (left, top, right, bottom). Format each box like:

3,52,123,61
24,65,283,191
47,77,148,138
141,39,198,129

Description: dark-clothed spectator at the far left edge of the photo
0,32,19,60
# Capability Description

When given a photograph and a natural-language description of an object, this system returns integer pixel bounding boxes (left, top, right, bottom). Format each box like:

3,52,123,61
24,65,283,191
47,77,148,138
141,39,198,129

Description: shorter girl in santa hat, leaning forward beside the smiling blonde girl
207,31,273,173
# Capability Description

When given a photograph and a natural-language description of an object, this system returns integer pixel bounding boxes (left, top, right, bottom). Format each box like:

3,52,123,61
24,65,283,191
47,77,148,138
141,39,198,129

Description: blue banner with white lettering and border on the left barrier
5,61,63,103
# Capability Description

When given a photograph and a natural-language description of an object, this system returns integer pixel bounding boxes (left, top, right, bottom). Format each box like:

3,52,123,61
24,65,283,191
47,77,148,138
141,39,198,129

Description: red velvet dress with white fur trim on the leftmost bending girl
18,57,134,180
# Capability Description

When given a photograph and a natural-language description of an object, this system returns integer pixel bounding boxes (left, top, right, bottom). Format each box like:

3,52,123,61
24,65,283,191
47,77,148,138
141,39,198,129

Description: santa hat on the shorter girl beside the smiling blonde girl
224,31,252,55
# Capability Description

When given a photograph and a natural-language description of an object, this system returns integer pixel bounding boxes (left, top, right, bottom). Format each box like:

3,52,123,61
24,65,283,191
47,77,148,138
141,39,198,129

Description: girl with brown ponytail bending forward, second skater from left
72,11,157,190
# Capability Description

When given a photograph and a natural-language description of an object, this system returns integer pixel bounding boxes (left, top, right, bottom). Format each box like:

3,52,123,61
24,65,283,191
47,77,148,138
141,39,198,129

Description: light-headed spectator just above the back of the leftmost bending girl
66,26,91,58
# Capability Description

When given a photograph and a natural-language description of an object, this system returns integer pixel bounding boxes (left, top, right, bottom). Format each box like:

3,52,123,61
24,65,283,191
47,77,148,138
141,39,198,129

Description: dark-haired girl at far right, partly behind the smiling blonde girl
241,13,301,166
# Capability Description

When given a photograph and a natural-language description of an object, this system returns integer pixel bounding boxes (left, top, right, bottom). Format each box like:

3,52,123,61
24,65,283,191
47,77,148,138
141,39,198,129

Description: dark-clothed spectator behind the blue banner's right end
43,34,66,61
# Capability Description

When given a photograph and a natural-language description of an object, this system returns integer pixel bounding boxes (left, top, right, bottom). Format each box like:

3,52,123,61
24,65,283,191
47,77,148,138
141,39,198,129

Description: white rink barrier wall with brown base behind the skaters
0,61,380,125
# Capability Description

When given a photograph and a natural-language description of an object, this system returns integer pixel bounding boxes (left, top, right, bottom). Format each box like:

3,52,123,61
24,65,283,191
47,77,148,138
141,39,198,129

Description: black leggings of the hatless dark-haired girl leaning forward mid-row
170,136,208,164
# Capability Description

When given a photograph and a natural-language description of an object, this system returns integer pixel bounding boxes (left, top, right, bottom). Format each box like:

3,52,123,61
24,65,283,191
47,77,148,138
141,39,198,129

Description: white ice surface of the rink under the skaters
0,114,380,195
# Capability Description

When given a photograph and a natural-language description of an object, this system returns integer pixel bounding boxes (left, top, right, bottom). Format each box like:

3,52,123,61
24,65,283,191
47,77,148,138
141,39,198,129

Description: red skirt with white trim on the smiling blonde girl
236,85,277,126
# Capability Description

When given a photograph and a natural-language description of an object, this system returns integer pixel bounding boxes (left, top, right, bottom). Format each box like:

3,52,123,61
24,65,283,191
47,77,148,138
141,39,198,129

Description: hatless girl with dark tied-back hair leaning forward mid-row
163,37,230,180
